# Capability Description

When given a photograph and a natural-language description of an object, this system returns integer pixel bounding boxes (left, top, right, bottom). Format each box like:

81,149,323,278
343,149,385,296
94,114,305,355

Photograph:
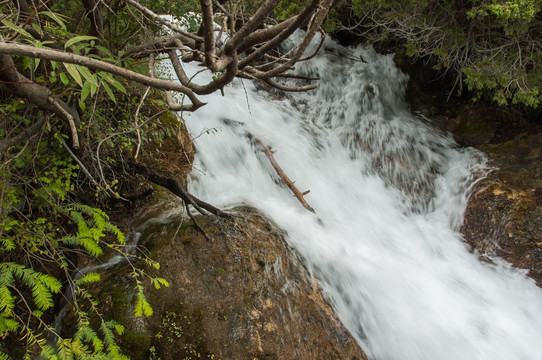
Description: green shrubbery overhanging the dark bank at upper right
343,0,542,108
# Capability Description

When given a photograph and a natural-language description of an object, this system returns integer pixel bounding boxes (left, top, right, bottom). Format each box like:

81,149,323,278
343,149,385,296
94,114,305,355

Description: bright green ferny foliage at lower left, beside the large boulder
0,129,169,360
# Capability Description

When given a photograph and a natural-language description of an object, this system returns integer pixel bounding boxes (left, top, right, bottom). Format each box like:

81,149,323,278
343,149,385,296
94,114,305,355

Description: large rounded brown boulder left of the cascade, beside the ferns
99,205,366,360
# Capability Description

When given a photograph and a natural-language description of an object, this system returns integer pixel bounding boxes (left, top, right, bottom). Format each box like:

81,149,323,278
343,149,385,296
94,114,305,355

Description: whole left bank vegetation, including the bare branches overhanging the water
0,0,332,360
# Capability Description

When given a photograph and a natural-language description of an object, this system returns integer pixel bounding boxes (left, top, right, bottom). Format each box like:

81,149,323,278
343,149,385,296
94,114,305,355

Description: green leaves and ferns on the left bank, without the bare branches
0,1,176,360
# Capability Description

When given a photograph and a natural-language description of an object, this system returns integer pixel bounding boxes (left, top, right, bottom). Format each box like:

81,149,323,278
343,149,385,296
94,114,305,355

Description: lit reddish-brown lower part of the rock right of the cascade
462,132,542,286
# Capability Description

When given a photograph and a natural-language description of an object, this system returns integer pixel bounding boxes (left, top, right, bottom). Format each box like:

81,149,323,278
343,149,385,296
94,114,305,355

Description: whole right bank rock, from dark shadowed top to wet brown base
399,62,542,287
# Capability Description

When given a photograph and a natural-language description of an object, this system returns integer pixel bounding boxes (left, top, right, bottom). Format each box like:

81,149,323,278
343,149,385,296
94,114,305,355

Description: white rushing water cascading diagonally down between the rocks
168,32,542,360
